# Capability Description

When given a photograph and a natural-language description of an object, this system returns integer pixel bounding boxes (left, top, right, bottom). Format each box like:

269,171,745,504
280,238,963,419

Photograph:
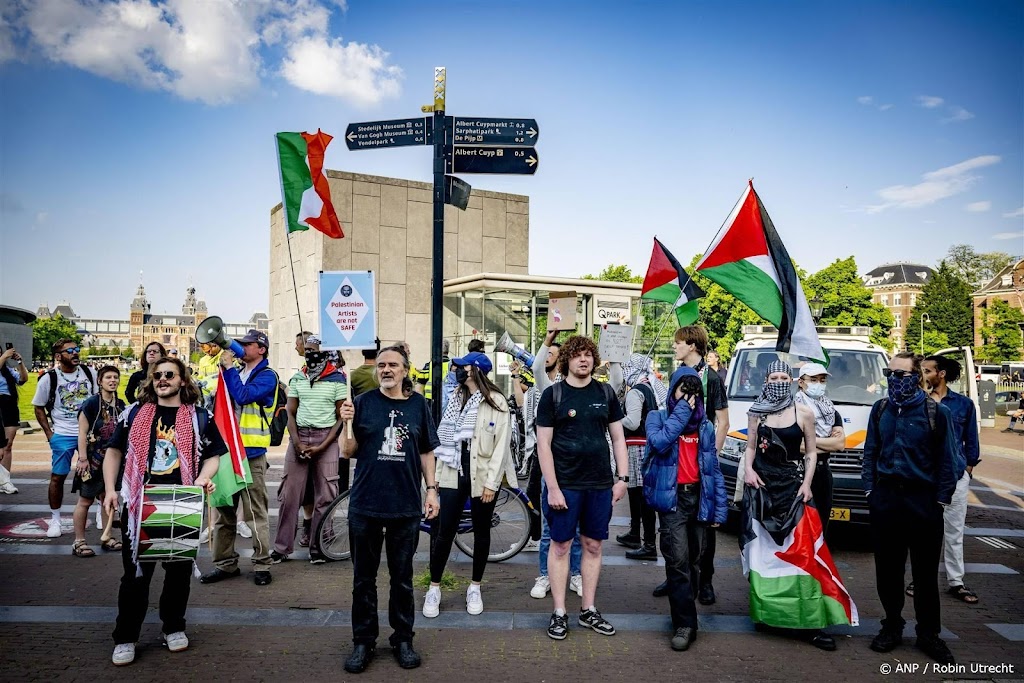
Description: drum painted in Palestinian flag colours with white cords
138,484,204,562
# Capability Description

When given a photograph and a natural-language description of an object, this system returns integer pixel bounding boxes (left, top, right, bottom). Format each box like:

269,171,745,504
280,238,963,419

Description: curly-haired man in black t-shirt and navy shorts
537,336,629,640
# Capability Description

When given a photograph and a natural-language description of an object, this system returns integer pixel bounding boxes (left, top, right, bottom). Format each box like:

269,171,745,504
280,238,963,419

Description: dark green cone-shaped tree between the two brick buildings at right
905,260,974,351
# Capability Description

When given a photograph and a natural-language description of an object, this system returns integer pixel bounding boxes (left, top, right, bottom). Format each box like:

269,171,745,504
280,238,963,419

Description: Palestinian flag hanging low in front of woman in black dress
739,487,859,629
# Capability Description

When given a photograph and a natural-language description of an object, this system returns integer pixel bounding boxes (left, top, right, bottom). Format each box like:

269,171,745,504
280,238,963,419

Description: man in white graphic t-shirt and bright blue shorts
32,339,99,539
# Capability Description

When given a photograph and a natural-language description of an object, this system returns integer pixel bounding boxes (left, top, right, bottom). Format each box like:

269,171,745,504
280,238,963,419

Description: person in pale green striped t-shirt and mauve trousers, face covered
270,334,348,564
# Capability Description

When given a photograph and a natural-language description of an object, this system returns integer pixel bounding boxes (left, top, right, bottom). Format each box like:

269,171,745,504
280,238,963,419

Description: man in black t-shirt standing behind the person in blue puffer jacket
671,325,729,605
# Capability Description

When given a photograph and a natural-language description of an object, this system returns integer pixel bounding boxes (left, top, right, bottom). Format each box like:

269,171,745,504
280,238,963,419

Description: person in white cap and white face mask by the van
793,362,846,530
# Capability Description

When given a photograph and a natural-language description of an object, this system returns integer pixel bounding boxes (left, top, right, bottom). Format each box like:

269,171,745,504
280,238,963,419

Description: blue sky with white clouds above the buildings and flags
0,0,1024,319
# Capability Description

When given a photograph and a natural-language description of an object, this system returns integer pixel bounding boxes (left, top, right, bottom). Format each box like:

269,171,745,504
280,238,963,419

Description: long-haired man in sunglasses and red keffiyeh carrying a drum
103,358,227,666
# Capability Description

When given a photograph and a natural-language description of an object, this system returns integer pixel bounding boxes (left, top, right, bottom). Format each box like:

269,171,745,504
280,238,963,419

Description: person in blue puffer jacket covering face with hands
643,366,728,651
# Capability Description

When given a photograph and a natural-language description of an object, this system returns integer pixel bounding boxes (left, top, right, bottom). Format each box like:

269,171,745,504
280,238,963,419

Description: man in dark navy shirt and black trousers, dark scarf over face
861,352,967,664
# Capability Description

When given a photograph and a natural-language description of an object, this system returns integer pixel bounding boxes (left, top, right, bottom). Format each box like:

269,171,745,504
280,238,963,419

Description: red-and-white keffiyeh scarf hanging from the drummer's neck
122,403,199,577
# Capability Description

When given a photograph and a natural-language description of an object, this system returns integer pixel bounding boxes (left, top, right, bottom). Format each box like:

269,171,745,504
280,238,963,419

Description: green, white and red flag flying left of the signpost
278,129,345,238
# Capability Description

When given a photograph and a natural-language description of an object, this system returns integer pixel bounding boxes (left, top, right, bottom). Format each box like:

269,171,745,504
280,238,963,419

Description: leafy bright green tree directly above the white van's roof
804,256,894,348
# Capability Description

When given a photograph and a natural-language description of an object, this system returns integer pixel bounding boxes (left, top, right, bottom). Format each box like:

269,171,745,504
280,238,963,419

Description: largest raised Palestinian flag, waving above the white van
696,181,828,365
